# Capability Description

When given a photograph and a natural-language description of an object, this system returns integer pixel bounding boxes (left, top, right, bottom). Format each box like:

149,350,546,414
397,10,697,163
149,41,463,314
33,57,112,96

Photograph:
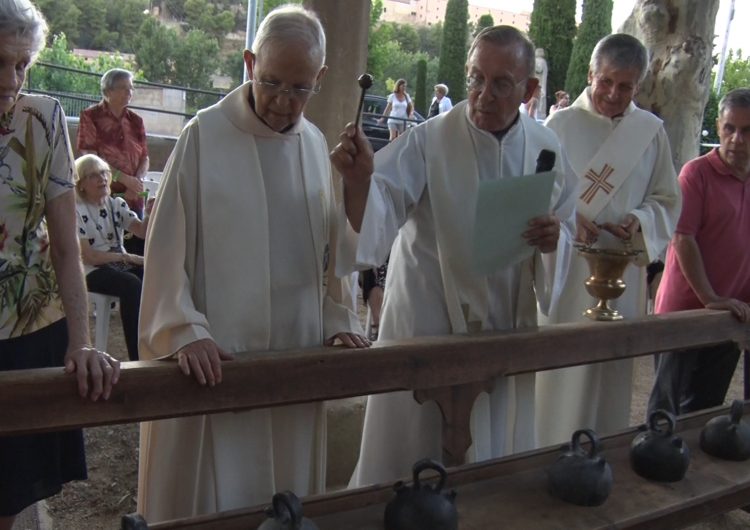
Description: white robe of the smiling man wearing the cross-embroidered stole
536,88,681,445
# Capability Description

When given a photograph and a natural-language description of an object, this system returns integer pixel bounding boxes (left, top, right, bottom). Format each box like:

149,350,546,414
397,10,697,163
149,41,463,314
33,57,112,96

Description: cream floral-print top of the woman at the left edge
0,95,73,340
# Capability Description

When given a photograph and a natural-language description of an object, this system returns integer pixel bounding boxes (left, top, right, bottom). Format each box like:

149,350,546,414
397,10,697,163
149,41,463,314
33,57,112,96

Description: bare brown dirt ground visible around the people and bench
39,312,750,530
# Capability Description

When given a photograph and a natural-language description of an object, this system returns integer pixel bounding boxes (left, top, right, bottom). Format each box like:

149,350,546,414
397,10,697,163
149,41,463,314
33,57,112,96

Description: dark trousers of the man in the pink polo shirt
648,342,740,415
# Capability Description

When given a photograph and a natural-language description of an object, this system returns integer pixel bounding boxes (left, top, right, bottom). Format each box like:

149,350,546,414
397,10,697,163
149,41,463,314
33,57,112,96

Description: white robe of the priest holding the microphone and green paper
338,102,575,485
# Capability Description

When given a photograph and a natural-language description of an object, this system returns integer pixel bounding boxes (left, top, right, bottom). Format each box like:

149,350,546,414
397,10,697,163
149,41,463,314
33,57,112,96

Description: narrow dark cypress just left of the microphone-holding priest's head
438,0,469,103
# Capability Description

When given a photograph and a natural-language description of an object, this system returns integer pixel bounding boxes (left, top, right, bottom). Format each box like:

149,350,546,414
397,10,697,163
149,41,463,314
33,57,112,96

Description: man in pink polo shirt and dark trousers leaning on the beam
649,88,750,414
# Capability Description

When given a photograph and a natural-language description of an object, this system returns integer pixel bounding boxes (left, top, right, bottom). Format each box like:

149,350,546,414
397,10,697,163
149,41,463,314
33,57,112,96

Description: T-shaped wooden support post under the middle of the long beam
414,379,494,466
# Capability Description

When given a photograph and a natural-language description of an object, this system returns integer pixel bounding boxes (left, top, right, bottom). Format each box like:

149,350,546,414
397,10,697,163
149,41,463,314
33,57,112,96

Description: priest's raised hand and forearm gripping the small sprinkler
331,123,374,232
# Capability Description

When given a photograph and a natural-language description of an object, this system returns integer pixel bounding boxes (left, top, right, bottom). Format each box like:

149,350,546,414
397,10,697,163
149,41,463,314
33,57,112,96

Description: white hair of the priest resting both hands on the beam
252,4,326,66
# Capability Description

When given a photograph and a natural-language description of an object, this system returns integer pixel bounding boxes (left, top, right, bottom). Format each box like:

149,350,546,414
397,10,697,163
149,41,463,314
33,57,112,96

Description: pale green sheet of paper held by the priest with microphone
474,171,555,274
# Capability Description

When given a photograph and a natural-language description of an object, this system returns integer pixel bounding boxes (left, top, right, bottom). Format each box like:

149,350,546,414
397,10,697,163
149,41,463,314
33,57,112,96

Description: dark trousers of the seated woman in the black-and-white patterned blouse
86,267,143,361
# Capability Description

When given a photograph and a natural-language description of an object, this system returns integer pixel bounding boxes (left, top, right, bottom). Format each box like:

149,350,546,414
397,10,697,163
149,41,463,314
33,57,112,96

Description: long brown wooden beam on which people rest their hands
0,310,750,436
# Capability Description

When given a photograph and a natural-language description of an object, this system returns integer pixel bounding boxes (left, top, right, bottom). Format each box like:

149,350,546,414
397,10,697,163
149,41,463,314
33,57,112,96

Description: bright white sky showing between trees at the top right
469,0,750,57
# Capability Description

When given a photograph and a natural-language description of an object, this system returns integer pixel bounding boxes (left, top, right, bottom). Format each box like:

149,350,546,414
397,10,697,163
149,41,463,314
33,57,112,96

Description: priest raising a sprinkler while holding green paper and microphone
332,26,575,485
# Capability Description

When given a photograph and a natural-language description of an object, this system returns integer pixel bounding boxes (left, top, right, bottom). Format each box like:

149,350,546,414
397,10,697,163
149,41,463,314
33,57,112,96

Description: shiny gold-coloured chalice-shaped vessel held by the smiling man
576,245,641,321
